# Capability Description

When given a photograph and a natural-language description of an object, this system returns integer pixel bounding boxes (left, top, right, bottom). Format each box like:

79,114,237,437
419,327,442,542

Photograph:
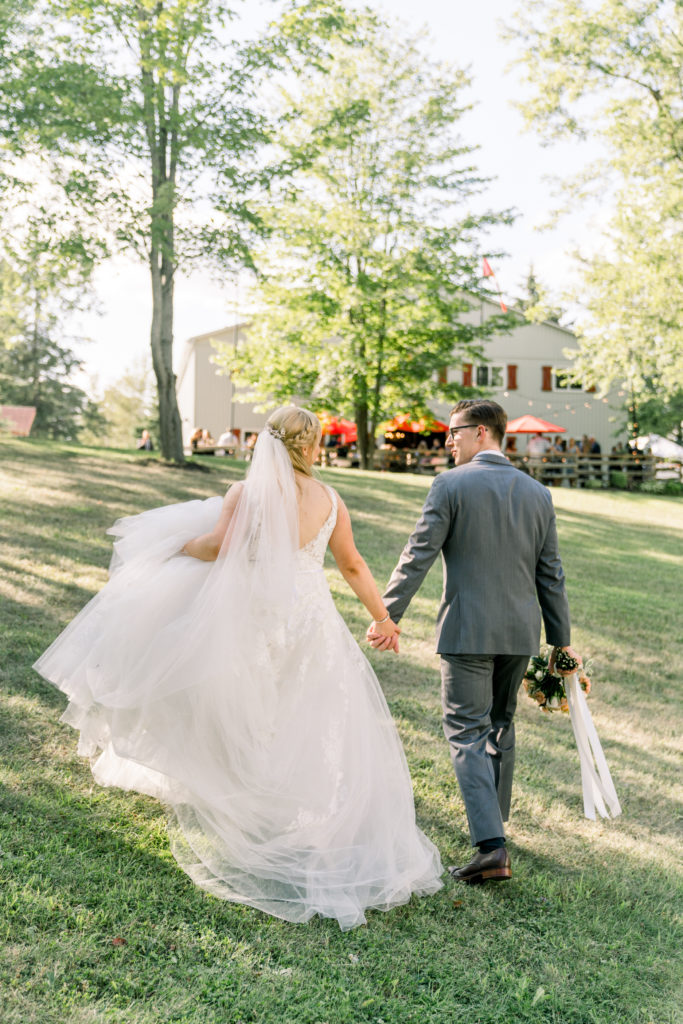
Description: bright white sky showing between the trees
71,0,597,388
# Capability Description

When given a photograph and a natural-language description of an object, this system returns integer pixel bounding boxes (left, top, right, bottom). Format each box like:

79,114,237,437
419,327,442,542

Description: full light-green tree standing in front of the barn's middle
218,22,508,467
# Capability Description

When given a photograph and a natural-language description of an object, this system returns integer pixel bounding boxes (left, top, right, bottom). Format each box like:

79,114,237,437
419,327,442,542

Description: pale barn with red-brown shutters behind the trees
177,299,620,453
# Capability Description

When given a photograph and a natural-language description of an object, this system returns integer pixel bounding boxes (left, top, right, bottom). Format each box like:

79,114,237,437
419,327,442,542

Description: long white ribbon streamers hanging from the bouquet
564,672,622,821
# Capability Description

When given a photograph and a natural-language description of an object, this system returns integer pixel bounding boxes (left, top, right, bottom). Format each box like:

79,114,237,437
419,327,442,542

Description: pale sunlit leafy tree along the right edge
509,0,683,404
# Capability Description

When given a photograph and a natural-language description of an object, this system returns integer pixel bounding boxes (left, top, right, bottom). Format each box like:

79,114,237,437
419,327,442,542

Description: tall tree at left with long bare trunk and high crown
0,0,358,462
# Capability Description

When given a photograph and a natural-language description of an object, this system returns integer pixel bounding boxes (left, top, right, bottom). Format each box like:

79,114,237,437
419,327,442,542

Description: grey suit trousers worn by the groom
441,654,528,846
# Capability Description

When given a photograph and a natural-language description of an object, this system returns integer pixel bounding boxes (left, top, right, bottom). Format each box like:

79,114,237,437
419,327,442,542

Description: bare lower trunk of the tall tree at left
150,248,184,464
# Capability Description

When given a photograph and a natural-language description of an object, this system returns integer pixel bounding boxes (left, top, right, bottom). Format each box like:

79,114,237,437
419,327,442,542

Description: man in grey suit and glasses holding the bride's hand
368,399,575,885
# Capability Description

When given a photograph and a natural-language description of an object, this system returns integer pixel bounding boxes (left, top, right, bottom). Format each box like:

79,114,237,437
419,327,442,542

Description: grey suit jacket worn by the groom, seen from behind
384,453,569,654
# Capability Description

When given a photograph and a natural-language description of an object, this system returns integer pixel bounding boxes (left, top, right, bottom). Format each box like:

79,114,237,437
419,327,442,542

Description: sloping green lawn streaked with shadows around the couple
0,439,683,1024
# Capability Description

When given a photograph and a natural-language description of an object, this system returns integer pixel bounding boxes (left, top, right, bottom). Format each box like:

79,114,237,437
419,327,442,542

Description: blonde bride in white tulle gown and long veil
35,406,442,930
